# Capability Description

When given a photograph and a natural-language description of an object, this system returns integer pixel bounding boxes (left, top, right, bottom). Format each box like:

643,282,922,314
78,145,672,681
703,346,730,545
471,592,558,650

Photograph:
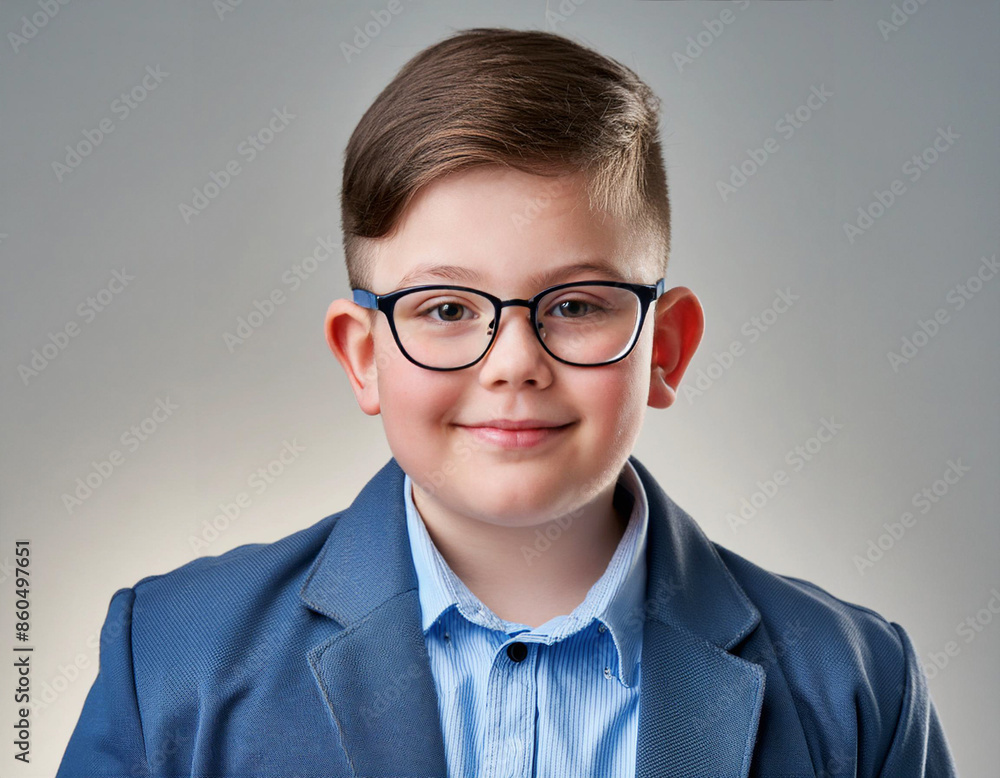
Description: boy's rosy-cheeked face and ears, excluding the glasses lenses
327,167,702,527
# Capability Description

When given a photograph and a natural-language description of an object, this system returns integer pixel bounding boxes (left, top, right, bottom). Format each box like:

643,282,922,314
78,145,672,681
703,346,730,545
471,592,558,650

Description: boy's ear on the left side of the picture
326,299,381,416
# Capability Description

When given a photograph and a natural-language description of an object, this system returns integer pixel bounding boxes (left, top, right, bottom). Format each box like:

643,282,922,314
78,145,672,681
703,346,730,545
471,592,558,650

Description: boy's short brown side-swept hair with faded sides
341,28,670,289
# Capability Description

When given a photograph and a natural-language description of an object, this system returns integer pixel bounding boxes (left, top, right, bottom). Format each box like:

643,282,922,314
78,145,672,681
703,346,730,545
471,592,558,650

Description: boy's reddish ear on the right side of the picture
649,286,705,408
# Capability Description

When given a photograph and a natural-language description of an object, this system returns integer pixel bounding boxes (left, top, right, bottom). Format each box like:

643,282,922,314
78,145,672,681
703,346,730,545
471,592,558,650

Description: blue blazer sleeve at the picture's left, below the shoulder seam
56,589,150,778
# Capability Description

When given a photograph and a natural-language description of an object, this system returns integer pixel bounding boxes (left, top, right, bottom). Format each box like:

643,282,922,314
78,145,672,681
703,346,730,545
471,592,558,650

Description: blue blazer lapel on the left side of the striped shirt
300,459,447,778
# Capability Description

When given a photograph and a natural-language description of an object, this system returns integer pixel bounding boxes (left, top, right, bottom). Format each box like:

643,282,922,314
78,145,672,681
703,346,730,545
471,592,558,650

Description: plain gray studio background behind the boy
0,0,1000,776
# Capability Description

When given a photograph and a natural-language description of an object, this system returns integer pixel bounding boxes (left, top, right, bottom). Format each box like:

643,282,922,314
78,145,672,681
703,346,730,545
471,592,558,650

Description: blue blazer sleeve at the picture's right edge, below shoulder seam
878,622,958,778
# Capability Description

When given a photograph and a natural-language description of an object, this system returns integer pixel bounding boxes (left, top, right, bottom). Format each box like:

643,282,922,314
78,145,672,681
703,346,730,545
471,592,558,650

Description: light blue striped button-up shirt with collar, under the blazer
401,461,649,778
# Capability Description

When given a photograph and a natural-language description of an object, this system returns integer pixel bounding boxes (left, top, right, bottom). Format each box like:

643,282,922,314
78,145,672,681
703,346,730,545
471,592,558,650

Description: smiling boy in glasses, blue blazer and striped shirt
59,29,955,778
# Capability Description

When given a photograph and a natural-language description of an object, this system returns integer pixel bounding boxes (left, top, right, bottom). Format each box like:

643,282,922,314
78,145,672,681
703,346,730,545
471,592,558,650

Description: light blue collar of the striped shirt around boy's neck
403,460,649,686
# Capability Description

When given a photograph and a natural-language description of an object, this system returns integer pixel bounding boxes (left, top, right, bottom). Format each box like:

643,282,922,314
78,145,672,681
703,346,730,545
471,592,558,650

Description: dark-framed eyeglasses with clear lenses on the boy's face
353,278,666,370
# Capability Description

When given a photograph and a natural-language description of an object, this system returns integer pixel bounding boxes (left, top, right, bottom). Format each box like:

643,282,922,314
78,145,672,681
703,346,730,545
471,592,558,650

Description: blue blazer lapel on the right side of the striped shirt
630,457,765,778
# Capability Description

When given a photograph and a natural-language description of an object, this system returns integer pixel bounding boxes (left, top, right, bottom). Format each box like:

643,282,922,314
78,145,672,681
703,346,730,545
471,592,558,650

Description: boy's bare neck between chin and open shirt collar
412,476,629,628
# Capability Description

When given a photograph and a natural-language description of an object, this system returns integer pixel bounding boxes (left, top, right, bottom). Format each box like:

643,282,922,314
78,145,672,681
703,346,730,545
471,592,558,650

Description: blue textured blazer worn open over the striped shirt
58,457,955,778
